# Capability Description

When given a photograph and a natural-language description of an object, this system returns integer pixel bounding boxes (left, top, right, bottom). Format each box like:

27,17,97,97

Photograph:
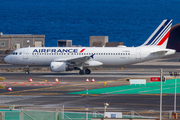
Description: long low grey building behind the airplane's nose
0,32,45,51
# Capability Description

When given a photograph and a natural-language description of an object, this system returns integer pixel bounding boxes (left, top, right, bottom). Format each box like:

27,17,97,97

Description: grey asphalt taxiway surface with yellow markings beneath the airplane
0,55,180,111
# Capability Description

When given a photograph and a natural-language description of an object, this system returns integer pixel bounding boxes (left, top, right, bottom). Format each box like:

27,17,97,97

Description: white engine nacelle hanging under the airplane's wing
50,62,74,72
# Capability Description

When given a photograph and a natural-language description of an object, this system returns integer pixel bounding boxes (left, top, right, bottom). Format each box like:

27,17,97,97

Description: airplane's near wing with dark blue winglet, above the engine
53,54,102,66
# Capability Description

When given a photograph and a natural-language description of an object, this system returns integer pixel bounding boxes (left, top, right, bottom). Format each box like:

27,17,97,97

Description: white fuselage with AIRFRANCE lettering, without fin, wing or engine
5,46,175,66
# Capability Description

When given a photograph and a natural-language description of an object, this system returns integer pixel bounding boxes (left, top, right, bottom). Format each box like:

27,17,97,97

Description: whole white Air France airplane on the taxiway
4,19,176,75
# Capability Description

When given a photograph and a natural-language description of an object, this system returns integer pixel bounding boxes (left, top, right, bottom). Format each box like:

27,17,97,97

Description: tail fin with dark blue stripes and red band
142,20,172,48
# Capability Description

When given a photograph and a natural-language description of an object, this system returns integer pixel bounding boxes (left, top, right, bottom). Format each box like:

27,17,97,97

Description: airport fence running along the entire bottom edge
0,107,180,120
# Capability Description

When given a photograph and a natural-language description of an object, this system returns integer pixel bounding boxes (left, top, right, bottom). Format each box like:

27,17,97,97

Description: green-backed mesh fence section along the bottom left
0,108,103,120
